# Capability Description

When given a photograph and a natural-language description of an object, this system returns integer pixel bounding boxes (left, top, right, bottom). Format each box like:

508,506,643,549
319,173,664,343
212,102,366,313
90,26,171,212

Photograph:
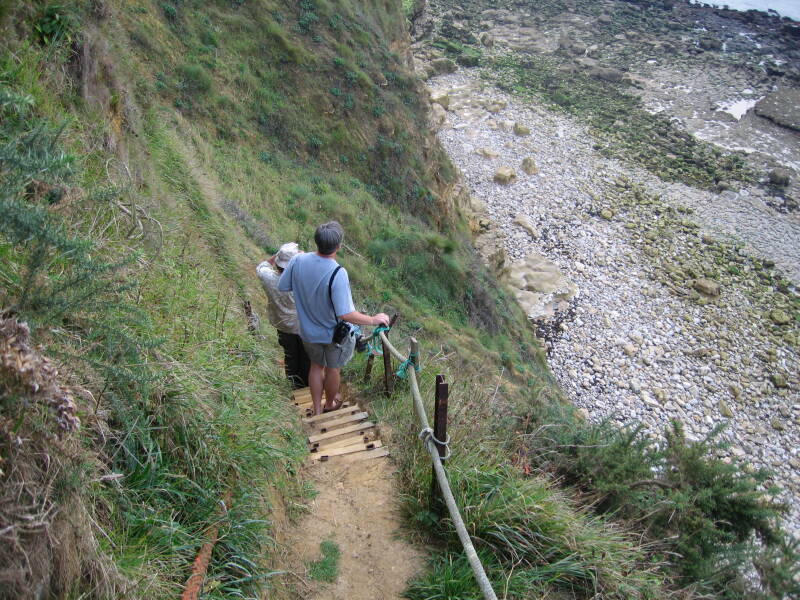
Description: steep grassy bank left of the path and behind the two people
0,1,536,598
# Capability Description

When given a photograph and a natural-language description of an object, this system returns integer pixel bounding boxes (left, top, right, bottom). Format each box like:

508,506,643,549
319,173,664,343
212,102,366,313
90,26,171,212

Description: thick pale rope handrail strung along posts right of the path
379,331,497,600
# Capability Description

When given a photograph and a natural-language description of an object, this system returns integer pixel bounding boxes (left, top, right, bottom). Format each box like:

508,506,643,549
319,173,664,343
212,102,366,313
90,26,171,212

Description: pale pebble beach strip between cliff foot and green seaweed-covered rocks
428,69,800,535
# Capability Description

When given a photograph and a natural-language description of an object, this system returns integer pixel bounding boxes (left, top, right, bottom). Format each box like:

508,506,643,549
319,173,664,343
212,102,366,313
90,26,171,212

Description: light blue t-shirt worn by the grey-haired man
278,252,355,344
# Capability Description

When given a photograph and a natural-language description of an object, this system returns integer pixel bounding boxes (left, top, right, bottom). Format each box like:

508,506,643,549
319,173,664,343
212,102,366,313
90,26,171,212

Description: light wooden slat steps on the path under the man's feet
292,386,389,463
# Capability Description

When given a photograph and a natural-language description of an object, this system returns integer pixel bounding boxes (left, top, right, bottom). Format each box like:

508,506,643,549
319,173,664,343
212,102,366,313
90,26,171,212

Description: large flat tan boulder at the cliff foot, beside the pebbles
503,252,578,319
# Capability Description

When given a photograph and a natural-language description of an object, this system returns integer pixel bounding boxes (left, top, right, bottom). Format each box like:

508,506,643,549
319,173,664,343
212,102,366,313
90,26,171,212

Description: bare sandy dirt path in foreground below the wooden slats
276,458,425,600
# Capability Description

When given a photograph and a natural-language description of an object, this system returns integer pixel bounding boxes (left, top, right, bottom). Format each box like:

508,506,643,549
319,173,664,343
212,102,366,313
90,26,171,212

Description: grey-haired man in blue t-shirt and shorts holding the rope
278,221,389,415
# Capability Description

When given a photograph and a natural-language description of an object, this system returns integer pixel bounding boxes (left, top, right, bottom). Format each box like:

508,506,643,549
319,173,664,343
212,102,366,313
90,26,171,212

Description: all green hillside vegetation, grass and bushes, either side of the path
0,0,796,600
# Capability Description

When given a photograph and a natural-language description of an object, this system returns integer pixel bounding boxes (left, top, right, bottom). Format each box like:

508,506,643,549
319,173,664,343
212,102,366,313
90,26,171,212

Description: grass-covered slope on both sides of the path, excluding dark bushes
2,0,792,598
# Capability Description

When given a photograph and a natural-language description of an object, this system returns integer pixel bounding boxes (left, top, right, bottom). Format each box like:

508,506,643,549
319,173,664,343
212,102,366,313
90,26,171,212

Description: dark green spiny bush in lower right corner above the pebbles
524,406,798,598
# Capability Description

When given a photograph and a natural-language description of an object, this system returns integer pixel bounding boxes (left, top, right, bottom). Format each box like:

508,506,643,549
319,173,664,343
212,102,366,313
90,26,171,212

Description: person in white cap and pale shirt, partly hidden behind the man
256,242,311,389
